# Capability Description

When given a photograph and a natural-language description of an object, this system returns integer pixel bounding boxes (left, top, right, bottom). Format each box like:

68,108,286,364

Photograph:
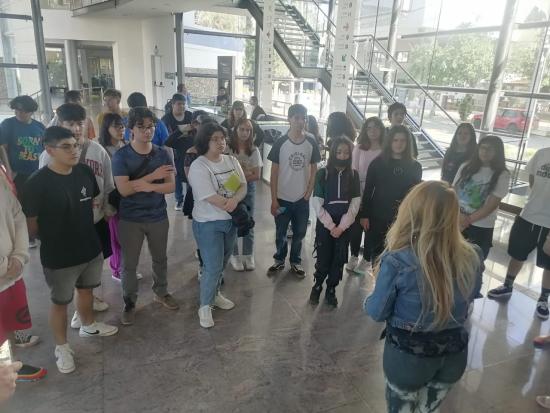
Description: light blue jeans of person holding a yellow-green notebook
193,219,237,307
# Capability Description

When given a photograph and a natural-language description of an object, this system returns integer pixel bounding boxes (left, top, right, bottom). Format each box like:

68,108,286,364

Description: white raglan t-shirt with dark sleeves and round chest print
267,134,321,202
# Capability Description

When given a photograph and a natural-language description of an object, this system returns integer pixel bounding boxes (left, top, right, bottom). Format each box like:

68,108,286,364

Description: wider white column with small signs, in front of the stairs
330,0,359,112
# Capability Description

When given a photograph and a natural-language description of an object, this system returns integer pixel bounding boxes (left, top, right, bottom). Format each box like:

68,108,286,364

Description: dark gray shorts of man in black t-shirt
44,254,103,305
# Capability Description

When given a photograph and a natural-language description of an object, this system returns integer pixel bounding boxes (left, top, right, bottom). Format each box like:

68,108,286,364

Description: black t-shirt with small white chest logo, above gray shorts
23,164,101,269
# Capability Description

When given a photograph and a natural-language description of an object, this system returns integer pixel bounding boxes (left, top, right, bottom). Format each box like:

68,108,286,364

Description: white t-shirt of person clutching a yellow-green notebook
188,155,246,222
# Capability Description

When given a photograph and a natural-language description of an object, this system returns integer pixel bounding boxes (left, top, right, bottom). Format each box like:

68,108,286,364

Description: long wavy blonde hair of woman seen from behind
382,181,480,329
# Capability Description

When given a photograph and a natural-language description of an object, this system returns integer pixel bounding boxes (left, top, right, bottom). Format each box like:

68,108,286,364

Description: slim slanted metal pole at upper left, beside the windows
31,0,52,123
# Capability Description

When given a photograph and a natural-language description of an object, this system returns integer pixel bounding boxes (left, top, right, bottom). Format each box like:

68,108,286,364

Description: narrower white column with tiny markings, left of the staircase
256,0,275,113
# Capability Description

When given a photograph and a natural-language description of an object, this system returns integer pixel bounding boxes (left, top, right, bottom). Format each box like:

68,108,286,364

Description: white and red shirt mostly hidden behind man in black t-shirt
38,140,116,224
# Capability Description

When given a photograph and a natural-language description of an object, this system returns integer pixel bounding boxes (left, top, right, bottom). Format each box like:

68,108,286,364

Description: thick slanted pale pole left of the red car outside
481,0,518,131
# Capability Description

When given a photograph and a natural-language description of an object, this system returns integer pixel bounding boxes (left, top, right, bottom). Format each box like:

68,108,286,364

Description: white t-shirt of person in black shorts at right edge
520,148,550,228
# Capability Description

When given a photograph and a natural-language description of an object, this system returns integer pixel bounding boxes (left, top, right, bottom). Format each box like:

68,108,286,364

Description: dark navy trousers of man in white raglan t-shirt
273,198,309,264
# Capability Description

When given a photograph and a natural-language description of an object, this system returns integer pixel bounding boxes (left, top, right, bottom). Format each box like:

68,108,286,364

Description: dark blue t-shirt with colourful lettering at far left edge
0,117,45,175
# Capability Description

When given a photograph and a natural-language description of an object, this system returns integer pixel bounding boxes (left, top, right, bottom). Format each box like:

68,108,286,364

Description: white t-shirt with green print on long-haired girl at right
453,164,510,228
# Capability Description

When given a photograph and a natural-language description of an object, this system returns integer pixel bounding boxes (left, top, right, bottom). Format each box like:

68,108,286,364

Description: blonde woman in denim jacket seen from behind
364,181,484,413
